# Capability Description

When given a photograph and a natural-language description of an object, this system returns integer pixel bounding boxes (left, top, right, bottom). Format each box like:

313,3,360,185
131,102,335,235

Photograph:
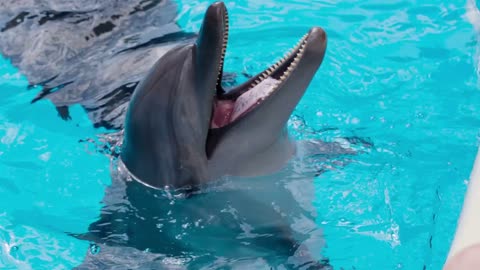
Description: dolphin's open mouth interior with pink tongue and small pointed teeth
210,12,308,129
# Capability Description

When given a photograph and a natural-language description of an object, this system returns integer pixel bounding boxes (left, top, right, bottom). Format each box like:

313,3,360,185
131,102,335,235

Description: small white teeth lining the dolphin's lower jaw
250,34,308,88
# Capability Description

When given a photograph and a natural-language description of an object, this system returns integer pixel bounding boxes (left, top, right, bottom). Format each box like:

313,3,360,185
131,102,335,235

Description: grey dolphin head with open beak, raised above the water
120,2,326,188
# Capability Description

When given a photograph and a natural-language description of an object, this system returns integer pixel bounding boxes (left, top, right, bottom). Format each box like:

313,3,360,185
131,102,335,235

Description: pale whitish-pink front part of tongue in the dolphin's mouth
230,77,278,121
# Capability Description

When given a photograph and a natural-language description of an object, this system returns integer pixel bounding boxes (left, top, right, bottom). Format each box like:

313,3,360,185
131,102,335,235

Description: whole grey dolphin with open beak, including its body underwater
76,2,354,269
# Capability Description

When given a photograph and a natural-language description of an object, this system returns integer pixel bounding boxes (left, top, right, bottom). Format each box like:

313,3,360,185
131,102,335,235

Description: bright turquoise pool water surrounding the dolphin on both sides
0,0,480,270
